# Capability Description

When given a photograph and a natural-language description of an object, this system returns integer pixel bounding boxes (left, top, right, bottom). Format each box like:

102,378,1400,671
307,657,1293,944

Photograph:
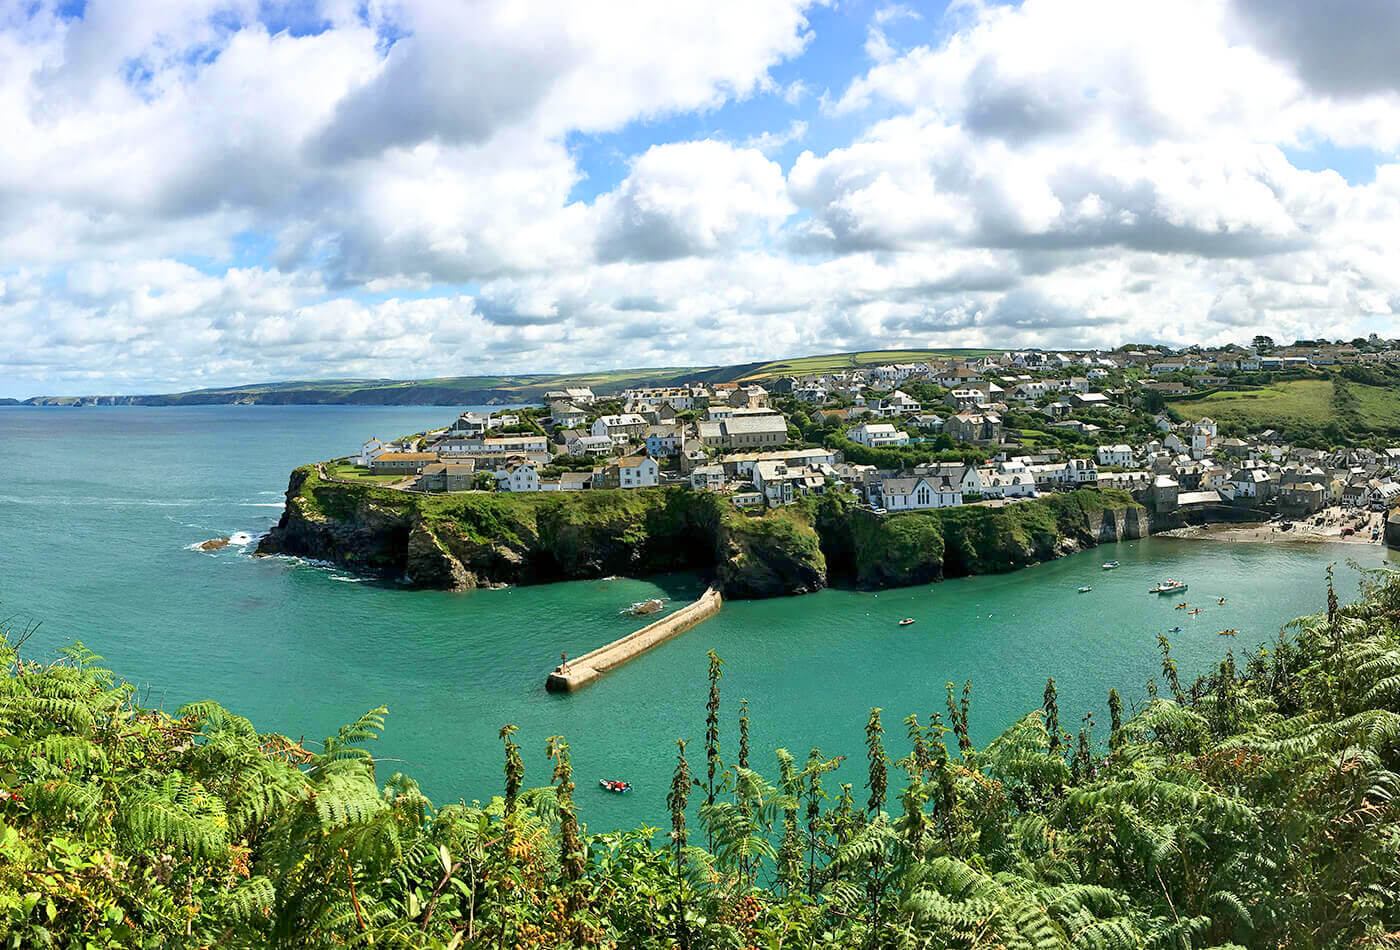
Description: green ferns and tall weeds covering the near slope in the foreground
0,574,1400,949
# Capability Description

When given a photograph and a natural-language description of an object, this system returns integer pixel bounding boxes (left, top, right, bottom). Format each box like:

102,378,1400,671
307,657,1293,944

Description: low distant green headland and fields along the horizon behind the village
21,350,994,406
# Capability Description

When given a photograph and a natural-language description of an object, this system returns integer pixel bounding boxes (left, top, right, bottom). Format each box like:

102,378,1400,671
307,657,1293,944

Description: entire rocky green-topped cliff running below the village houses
258,466,1151,599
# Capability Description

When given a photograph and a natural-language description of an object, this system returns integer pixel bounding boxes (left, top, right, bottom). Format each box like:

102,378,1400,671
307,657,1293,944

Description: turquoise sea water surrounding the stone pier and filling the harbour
0,407,1386,828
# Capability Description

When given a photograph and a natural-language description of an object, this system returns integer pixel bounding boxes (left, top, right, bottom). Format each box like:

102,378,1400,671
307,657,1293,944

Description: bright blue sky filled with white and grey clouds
0,0,1400,397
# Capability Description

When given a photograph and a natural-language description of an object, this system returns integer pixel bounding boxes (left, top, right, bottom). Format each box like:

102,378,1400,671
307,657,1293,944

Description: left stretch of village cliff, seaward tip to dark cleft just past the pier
258,466,826,597
